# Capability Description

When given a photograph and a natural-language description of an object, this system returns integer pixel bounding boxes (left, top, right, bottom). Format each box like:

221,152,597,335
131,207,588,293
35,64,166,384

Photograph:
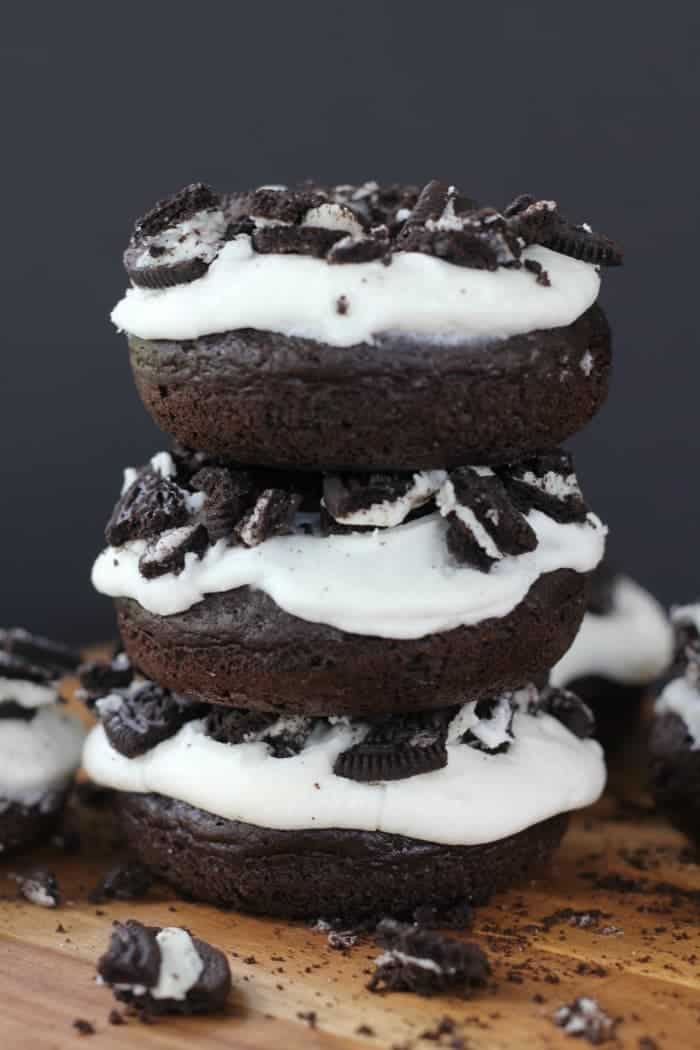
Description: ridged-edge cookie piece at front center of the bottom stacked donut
333,709,453,783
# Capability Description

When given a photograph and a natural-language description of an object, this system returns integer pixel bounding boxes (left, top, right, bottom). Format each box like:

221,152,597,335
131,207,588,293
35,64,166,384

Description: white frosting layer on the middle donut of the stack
92,510,607,638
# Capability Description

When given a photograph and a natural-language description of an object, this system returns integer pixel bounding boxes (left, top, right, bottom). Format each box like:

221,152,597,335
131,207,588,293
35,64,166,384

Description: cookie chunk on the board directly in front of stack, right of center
367,919,491,998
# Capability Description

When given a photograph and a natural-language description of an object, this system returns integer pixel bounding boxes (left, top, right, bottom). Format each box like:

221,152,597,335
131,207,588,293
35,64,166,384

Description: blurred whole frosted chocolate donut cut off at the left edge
0,628,84,855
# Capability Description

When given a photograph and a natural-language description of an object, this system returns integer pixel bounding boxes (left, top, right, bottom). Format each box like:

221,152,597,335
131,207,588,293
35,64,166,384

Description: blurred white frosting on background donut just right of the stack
551,576,673,686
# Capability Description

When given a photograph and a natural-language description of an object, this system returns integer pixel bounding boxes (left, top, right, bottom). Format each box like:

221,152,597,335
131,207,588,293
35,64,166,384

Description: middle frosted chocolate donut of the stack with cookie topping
93,449,604,715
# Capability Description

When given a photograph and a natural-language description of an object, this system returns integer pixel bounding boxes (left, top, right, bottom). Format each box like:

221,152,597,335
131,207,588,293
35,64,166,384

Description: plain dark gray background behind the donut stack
0,8,700,641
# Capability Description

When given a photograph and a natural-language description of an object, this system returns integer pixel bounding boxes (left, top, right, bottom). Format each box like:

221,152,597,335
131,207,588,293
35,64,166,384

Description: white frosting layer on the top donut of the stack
111,234,600,347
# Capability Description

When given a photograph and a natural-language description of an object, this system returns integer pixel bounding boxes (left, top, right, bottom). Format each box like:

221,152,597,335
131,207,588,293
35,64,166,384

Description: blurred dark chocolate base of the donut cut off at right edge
649,712,700,844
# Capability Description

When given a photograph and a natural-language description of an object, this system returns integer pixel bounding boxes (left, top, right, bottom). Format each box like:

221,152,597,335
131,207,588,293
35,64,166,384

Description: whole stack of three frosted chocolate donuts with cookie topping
85,182,620,919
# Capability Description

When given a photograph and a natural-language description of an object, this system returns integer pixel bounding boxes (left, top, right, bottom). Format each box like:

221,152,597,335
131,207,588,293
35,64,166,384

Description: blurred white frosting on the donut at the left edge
0,705,85,805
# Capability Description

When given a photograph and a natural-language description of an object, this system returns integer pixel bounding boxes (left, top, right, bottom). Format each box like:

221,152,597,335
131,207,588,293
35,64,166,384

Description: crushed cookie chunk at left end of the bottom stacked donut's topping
96,681,207,758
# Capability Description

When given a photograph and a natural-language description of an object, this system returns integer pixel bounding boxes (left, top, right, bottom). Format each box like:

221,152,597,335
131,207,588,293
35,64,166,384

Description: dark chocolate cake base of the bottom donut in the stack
115,794,568,920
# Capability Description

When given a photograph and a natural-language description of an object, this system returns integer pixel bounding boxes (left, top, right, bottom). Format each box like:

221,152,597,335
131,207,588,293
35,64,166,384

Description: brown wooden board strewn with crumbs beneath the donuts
0,676,700,1050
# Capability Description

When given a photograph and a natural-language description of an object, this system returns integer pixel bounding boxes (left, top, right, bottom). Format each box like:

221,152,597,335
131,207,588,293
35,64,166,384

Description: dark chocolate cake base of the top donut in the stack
129,306,611,470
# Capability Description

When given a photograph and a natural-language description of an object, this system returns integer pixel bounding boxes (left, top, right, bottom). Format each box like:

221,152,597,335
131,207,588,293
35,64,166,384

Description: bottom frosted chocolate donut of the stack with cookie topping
84,680,604,920
